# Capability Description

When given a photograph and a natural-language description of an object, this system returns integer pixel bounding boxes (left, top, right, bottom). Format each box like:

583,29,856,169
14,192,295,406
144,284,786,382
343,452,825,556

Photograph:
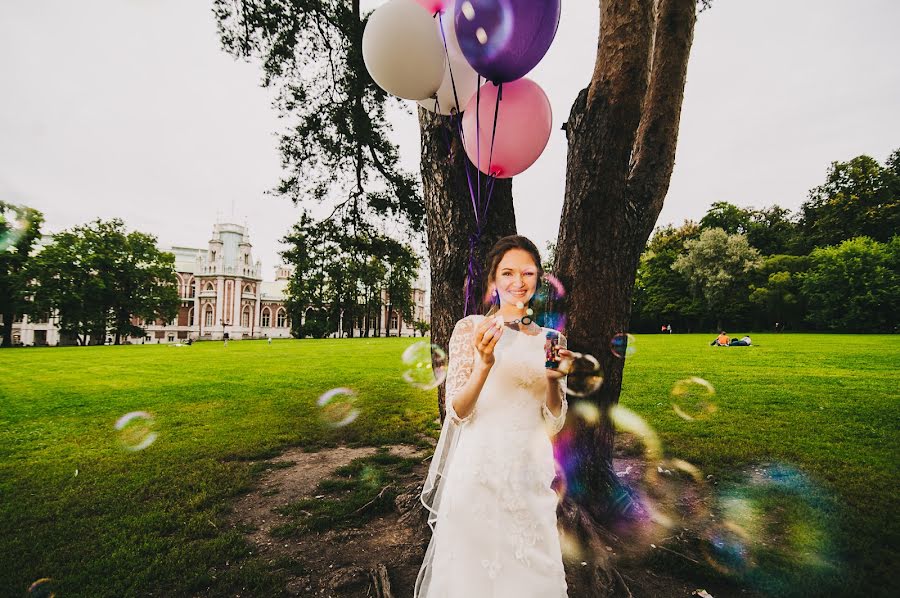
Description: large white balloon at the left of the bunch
363,0,446,100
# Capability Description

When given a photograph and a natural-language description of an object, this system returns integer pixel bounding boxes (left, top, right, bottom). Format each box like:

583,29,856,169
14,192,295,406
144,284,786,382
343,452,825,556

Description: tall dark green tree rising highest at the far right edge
800,150,900,251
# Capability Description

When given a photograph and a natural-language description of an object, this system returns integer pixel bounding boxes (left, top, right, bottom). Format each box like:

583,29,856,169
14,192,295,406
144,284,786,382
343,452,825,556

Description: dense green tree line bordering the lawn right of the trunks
631,150,900,332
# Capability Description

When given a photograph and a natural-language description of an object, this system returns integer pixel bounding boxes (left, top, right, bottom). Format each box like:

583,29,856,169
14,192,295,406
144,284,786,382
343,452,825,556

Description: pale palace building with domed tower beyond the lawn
7,224,431,346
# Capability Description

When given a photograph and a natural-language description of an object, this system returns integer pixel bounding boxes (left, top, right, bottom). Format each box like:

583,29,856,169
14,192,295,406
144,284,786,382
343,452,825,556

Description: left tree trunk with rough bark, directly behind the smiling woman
419,108,516,420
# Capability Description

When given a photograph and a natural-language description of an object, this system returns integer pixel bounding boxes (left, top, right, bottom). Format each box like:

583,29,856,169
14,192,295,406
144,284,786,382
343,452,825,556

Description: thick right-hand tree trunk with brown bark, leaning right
554,0,696,596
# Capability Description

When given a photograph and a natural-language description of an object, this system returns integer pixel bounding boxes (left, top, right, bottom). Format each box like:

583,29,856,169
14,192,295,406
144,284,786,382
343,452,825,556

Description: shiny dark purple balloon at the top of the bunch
453,0,560,84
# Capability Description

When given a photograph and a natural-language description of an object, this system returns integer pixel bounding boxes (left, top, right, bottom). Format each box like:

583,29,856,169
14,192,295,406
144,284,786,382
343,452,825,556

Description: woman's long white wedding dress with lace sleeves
415,316,568,598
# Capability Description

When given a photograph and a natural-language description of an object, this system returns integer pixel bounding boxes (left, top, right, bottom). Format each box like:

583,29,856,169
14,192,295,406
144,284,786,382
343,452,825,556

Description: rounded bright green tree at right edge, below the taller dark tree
800,236,900,332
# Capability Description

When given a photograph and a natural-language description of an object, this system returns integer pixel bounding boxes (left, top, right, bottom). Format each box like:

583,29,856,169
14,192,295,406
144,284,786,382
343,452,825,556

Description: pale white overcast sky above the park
0,0,900,279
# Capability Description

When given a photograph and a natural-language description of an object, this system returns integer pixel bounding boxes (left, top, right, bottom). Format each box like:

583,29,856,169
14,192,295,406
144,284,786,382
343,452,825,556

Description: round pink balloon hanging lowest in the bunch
463,78,553,179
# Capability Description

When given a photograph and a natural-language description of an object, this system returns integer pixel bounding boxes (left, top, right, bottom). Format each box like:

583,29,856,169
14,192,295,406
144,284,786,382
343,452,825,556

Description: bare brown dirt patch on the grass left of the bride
230,445,431,597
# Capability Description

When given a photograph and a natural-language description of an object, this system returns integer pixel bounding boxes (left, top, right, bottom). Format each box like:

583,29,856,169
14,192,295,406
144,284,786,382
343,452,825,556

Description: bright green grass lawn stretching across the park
0,335,900,597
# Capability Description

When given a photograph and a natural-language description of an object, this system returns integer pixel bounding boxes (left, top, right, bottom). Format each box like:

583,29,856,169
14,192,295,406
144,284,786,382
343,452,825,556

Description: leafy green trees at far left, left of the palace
0,214,180,347
